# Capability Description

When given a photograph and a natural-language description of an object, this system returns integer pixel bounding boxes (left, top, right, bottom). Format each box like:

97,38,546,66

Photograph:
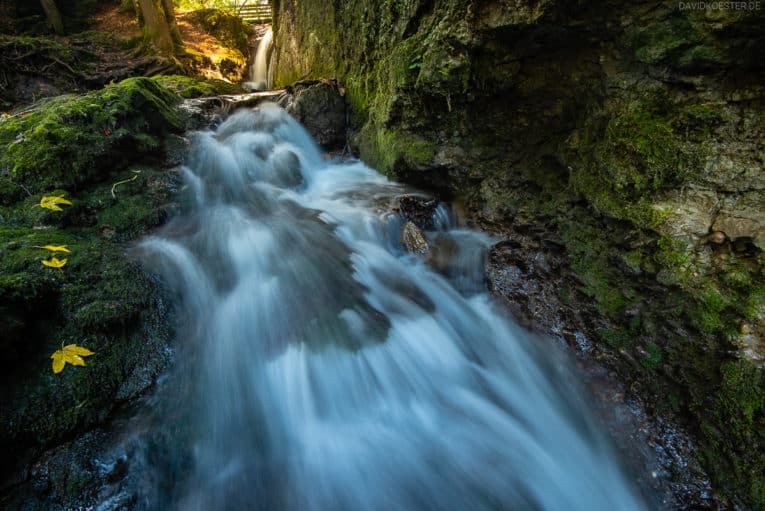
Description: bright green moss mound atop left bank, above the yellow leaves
0,78,185,199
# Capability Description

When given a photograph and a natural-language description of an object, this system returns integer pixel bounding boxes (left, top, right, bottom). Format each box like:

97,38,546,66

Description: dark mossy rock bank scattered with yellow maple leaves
0,77,224,493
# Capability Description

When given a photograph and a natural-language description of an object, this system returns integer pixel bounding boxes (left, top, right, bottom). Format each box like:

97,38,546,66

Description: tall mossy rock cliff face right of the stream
274,0,765,506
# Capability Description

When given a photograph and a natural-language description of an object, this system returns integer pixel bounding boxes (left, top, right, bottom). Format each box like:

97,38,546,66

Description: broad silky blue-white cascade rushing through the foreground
131,104,644,511
